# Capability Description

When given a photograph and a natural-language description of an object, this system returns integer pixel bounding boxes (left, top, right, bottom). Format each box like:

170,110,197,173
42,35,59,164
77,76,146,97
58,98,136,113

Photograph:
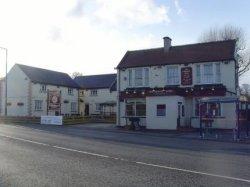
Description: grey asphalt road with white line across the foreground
0,124,250,186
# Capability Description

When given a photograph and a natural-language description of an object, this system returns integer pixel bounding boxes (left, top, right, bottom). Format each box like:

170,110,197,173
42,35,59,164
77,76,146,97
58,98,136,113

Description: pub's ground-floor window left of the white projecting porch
126,101,146,116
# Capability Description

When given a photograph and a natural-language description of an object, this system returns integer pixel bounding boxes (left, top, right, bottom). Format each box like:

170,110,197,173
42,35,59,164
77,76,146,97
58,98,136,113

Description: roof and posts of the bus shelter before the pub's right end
199,96,250,139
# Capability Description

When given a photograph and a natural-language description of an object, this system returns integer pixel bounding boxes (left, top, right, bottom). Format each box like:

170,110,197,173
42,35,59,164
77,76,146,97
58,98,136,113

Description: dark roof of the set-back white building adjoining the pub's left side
74,74,116,90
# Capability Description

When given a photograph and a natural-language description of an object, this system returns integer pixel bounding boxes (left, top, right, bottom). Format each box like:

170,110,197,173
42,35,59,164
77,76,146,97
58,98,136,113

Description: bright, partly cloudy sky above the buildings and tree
0,0,250,83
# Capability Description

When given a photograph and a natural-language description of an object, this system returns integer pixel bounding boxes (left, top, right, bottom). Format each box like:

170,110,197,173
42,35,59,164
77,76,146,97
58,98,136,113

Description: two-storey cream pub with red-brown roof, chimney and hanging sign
117,37,238,130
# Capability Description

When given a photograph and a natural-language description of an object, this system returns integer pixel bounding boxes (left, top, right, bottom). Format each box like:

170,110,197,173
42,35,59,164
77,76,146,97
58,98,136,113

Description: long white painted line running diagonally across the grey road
0,134,250,183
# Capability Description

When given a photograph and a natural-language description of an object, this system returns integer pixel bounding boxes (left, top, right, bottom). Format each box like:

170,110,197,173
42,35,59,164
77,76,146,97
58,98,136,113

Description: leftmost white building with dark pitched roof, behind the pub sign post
0,64,79,116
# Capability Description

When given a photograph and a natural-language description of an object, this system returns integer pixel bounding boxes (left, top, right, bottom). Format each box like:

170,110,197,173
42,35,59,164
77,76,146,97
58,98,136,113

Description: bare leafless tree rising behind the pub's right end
199,25,250,76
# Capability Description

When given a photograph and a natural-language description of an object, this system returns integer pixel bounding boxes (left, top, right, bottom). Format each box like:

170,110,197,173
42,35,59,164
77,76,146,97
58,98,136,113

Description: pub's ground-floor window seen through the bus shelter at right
195,100,221,116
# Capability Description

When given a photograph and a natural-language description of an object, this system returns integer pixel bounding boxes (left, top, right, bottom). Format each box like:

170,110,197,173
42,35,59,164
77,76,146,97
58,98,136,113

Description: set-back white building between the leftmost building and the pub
74,74,117,116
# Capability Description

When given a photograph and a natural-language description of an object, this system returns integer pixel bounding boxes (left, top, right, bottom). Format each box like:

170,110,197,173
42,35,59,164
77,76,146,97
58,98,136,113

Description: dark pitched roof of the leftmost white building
16,64,79,88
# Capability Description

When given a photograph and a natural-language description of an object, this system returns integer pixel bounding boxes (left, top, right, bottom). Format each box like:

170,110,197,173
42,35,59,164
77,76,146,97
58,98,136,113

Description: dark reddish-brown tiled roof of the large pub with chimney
117,40,236,69
